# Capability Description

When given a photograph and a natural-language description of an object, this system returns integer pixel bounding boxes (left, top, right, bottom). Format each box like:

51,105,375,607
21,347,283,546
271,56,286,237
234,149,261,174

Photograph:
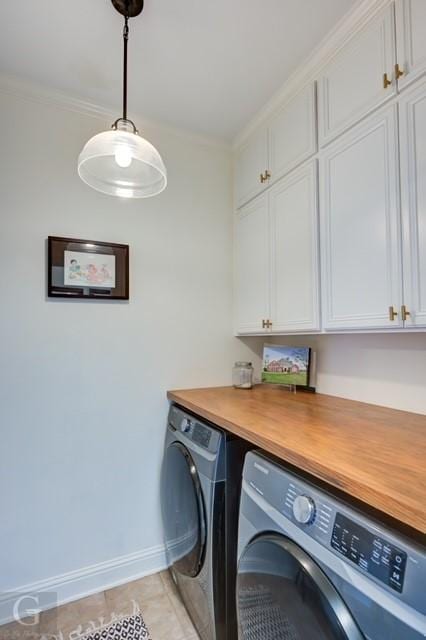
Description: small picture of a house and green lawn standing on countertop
262,344,311,387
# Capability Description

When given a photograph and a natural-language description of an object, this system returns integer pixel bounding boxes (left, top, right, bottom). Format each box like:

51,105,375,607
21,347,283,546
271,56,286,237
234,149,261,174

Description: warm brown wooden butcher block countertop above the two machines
168,385,426,534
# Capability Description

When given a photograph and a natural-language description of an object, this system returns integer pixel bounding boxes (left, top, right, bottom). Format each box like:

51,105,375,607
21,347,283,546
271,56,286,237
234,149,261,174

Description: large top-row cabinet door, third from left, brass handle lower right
318,6,396,145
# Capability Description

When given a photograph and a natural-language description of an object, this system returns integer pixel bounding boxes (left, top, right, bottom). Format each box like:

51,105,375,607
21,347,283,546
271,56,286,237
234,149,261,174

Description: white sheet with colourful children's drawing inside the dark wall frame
64,251,115,289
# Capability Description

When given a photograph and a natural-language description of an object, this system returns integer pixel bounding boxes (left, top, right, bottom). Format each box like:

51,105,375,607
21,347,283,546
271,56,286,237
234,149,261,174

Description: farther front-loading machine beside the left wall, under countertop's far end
161,405,248,640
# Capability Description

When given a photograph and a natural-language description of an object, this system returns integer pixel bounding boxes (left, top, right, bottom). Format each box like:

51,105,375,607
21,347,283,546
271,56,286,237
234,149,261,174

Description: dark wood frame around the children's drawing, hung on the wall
47,236,129,300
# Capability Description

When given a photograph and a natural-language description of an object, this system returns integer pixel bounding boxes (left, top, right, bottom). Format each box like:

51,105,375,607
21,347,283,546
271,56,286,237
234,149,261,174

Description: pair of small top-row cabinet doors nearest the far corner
235,83,317,207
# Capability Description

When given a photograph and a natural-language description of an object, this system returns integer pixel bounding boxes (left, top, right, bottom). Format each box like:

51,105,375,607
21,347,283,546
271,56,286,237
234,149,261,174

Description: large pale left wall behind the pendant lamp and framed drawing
0,86,262,618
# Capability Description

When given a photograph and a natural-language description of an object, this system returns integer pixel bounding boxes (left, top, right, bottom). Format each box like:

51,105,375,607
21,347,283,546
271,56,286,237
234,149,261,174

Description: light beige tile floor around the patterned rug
0,571,198,640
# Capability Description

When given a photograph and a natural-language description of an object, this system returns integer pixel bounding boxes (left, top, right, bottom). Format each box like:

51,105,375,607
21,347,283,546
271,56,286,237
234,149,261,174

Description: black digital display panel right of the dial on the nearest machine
331,513,407,593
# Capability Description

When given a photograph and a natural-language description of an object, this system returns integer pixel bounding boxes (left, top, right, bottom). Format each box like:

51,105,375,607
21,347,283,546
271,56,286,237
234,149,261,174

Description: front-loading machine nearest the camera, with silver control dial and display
236,452,426,640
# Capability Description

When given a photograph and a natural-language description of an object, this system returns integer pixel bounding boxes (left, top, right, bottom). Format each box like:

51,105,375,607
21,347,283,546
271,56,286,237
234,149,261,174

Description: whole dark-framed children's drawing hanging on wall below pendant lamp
47,236,129,300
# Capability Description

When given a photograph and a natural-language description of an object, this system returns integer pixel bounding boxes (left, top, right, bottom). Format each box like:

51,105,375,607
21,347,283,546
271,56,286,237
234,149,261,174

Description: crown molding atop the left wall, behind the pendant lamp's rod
0,73,231,151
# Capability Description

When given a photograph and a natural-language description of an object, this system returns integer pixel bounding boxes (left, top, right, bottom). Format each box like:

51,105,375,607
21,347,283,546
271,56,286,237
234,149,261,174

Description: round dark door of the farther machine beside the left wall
161,442,206,577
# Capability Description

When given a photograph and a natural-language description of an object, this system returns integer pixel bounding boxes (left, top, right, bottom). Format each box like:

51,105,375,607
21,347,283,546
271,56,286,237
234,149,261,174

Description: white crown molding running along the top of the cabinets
232,0,393,149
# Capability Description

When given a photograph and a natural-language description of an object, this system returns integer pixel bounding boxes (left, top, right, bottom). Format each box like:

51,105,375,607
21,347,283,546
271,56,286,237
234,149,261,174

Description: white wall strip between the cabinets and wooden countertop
268,333,426,413
